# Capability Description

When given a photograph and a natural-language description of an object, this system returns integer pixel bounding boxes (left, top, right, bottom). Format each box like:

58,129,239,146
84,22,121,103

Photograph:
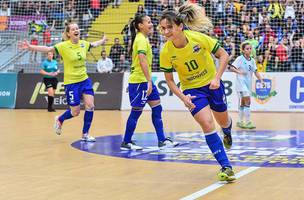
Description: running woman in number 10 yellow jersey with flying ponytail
160,3,235,181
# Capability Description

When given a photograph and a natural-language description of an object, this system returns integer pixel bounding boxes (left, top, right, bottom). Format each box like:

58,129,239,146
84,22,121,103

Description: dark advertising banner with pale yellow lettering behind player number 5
16,73,123,110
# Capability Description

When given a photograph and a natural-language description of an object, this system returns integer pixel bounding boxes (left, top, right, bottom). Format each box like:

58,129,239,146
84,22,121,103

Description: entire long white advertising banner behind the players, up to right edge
121,72,304,112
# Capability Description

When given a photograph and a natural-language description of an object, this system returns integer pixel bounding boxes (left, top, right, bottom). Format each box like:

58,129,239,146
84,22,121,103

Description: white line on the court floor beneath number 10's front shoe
180,167,260,200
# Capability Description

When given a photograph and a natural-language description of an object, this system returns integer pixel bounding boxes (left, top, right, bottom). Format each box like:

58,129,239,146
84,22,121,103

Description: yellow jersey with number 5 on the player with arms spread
54,40,91,85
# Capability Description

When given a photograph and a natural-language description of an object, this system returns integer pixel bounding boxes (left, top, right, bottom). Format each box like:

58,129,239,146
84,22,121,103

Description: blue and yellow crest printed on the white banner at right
252,78,277,104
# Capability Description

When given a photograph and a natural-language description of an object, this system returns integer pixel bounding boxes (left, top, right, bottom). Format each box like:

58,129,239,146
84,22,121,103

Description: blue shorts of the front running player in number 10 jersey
183,81,227,116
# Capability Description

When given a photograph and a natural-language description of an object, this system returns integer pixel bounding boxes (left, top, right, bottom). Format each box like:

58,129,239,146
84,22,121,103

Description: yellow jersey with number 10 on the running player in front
160,30,220,90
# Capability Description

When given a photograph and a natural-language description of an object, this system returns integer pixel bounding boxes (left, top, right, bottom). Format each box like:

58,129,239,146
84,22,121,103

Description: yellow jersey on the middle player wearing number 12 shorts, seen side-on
129,32,152,83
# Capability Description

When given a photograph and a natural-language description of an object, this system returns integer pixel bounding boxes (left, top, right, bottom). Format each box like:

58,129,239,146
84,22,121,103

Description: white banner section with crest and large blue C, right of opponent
251,73,304,112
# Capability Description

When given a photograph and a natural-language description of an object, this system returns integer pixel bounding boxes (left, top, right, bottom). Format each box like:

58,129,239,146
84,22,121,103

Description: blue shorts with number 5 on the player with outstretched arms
64,78,94,106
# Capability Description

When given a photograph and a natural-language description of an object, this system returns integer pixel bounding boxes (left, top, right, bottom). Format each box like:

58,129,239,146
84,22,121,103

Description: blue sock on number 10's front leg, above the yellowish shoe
205,132,232,168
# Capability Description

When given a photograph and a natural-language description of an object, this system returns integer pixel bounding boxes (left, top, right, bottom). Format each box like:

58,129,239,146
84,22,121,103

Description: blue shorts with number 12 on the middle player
129,82,160,108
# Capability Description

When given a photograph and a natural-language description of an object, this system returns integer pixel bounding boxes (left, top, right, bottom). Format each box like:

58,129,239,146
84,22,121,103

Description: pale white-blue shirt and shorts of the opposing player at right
232,55,257,94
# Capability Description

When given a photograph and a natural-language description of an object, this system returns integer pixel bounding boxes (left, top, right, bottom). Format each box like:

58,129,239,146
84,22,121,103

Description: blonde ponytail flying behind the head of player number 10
176,2,213,33
